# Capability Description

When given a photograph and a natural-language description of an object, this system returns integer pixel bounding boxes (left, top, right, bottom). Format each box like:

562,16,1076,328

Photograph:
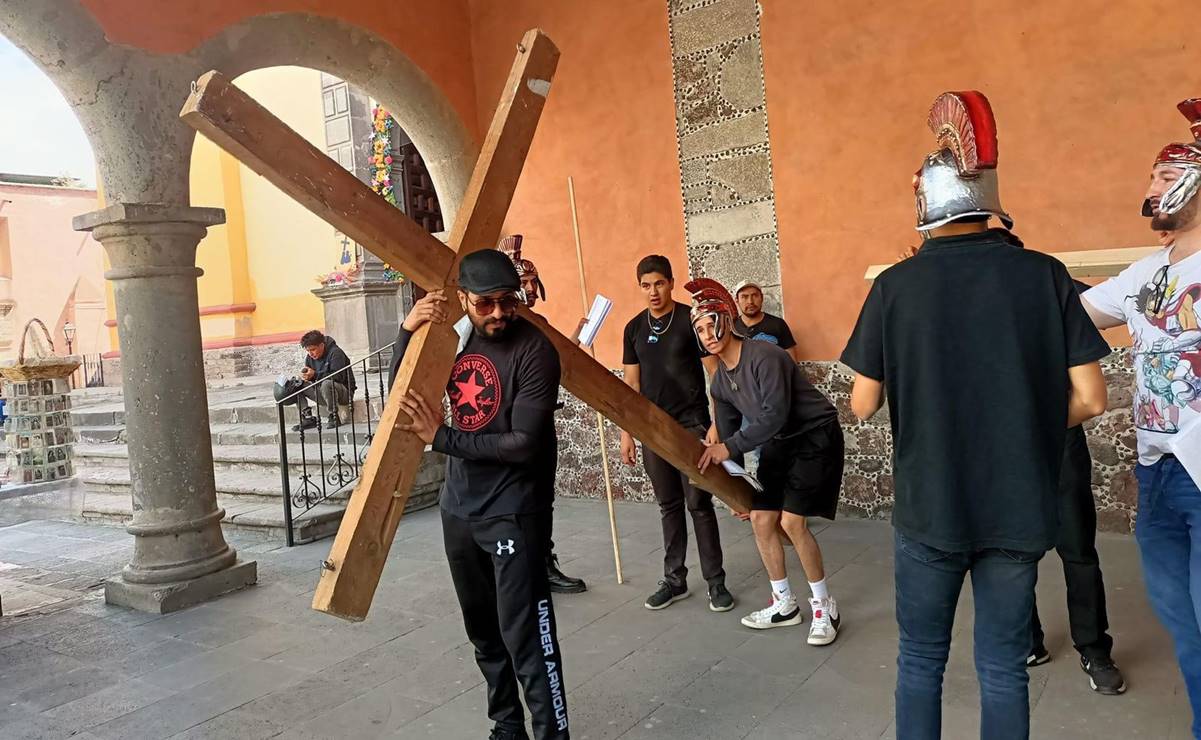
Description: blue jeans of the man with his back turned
895,532,1042,740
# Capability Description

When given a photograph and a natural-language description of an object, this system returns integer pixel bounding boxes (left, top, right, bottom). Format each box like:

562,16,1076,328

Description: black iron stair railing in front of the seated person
275,345,393,548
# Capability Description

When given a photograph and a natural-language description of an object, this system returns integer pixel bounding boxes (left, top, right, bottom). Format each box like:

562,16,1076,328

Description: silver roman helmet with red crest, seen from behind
913,90,1014,237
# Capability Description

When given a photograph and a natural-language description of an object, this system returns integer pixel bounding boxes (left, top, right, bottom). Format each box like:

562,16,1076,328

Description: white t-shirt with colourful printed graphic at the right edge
1085,247,1201,465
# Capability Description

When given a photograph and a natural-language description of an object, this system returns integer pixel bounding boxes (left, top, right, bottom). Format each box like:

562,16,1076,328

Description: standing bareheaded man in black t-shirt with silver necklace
621,255,734,611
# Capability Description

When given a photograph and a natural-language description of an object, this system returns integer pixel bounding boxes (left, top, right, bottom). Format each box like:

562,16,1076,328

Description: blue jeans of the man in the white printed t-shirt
1134,455,1201,738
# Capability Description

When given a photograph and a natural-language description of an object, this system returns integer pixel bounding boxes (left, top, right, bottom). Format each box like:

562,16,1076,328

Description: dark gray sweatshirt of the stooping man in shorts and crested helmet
710,341,838,455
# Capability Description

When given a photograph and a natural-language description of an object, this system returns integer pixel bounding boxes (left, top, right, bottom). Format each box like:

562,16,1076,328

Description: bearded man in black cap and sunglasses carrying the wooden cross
393,249,569,740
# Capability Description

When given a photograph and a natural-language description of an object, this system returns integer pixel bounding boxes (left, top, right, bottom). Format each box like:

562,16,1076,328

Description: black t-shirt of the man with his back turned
842,229,1110,551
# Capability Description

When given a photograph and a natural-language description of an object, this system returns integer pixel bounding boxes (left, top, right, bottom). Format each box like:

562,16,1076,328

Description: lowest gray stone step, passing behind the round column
82,490,345,544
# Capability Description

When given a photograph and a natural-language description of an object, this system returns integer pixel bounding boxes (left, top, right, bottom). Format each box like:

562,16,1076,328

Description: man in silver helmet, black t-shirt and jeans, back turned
842,91,1110,740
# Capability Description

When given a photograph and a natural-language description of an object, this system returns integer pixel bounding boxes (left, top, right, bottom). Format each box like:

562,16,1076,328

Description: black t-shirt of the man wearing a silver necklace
621,303,709,426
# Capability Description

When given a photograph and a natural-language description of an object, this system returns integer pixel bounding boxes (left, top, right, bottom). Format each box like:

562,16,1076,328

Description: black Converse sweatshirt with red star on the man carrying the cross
389,317,561,519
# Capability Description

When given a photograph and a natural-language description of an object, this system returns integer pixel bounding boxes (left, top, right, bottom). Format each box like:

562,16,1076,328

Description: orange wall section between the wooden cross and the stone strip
471,0,687,368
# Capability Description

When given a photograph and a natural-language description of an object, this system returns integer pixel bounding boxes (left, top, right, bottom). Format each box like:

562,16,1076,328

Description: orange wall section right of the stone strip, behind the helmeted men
761,0,1201,359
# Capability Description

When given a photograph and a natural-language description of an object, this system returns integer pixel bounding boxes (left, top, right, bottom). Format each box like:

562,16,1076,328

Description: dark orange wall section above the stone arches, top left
72,0,477,145
